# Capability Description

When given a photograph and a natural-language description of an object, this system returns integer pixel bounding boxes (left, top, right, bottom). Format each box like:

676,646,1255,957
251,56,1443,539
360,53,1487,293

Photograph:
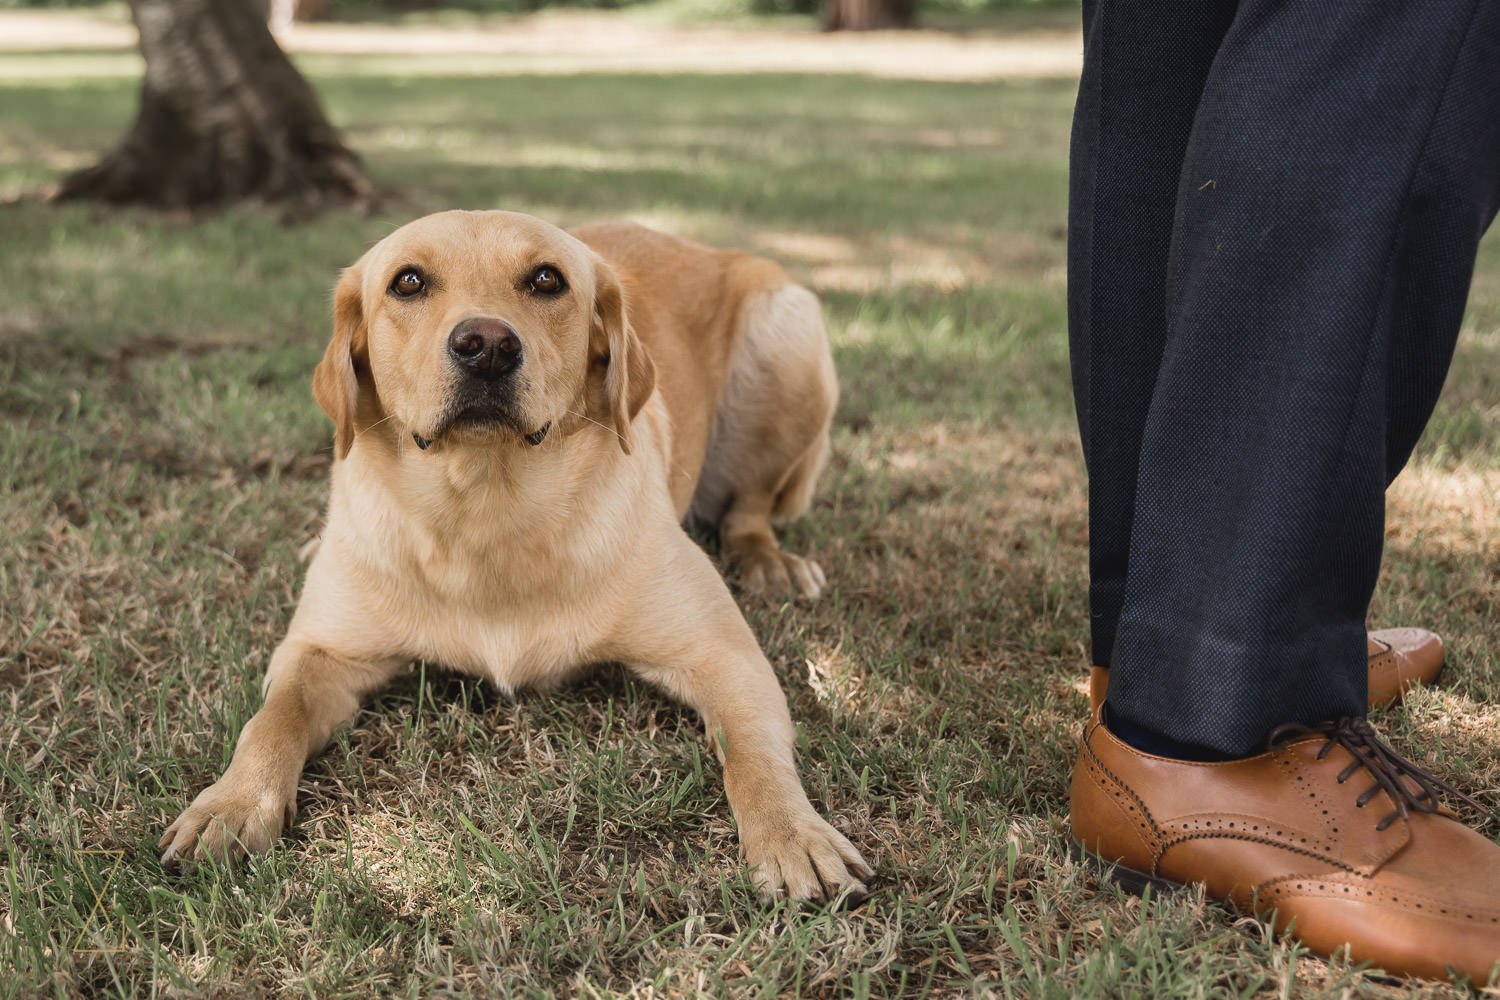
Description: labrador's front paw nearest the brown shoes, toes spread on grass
741,811,875,903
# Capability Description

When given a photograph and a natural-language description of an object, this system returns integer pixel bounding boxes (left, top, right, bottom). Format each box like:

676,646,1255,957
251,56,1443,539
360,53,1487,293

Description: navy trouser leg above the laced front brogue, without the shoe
1104,0,1500,757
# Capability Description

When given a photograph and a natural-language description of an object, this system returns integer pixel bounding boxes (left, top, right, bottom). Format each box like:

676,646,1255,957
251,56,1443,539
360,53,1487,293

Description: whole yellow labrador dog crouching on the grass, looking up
161,211,872,898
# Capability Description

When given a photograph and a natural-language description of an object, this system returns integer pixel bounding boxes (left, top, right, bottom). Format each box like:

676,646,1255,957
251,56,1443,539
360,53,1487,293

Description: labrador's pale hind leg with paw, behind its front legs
692,283,839,598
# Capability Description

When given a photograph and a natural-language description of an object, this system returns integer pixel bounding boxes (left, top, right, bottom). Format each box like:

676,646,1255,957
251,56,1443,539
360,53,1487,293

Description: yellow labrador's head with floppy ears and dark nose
312,211,656,457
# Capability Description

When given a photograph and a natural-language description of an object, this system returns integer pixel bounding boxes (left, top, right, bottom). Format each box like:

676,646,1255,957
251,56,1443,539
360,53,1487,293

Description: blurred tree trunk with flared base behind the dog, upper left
53,0,374,208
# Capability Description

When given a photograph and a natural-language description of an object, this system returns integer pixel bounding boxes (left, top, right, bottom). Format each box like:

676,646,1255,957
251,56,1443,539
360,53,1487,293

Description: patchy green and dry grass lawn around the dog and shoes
0,9,1500,997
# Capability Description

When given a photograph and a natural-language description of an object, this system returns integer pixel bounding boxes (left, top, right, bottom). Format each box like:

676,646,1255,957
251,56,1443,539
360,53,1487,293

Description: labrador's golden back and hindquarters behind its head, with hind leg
573,222,839,594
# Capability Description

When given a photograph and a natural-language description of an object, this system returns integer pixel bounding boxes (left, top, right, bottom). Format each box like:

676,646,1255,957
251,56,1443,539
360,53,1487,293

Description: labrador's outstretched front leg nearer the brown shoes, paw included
617,535,875,900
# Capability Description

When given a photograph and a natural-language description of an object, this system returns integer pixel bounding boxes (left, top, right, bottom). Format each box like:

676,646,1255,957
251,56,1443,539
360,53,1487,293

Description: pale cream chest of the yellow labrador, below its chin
316,442,657,688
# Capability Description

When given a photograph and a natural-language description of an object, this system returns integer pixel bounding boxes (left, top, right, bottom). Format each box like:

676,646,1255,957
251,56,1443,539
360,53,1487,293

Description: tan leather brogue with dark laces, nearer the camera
1071,712,1500,987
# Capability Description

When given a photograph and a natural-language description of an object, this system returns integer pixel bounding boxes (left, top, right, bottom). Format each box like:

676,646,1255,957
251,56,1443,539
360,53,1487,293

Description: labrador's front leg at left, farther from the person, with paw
158,639,401,862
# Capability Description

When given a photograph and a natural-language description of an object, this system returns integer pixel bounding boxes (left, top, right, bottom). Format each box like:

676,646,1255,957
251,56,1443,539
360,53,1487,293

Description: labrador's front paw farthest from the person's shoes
156,775,297,864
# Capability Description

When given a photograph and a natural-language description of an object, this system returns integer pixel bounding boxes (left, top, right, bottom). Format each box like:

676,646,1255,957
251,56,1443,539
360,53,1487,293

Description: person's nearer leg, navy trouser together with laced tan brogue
1070,0,1500,985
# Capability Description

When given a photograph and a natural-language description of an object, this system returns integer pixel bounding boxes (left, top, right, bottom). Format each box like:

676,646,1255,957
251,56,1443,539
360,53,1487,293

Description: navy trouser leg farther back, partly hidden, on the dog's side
1068,0,1235,666
